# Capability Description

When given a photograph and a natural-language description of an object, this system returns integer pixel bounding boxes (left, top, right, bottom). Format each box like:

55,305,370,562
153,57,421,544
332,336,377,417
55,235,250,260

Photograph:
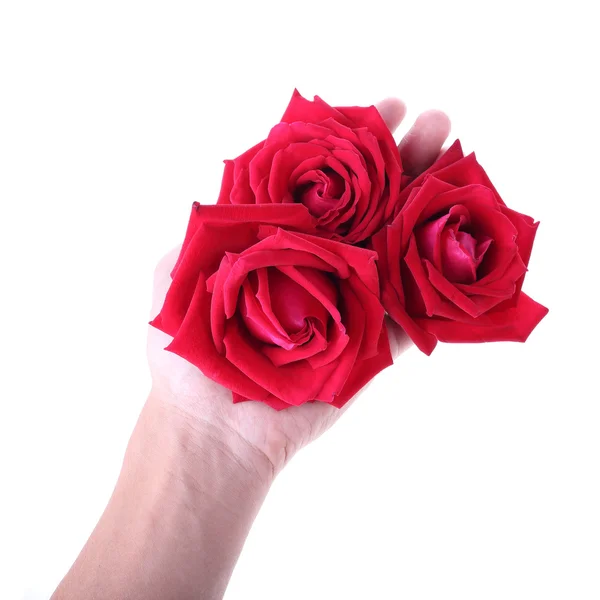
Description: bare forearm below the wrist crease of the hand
53,398,272,600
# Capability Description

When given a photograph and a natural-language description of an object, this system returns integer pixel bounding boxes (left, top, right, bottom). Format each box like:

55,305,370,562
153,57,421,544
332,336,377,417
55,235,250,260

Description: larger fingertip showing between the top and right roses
398,110,450,175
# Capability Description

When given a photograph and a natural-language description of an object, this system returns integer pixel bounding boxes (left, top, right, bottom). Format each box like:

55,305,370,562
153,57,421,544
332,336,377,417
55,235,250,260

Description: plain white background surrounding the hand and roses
0,0,600,600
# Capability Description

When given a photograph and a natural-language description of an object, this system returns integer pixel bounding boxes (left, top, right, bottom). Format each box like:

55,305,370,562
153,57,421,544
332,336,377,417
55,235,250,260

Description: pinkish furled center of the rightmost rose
415,205,492,284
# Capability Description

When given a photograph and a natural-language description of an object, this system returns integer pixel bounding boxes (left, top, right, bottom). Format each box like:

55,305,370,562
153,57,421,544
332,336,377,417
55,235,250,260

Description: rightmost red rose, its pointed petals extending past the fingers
372,141,548,354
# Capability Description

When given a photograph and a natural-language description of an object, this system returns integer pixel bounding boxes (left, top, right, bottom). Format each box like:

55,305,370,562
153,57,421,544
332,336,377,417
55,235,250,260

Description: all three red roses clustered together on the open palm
152,92,548,410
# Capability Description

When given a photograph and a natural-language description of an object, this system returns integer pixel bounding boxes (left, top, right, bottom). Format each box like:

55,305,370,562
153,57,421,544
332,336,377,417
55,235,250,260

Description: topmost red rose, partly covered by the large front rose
218,91,402,244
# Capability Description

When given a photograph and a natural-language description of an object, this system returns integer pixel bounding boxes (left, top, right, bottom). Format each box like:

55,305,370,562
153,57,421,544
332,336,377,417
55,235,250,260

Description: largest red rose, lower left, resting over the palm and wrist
152,203,392,409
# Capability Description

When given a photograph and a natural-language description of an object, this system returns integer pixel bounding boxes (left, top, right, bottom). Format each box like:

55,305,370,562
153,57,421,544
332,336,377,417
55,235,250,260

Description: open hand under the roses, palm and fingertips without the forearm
148,98,450,477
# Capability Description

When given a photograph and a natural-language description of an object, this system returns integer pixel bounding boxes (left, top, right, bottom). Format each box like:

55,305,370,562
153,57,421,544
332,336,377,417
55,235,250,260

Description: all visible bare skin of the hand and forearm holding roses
52,98,450,600
